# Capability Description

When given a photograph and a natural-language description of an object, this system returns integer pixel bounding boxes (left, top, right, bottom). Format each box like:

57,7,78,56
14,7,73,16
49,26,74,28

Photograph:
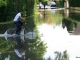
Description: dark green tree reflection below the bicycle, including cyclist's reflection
0,32,46,60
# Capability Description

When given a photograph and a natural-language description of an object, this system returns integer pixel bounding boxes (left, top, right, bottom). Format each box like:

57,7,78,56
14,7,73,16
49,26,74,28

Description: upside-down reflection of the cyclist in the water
14,37,25,59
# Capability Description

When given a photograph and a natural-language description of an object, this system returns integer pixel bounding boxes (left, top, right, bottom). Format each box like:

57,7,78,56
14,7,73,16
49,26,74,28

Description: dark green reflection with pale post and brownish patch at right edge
62,9,80,35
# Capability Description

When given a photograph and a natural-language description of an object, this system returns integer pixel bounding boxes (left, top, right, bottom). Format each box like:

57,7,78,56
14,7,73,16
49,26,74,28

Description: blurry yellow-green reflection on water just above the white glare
36,10,62,25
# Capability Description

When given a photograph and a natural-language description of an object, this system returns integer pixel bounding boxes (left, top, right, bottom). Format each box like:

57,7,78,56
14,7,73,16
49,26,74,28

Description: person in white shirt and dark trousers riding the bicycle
13,10,25,35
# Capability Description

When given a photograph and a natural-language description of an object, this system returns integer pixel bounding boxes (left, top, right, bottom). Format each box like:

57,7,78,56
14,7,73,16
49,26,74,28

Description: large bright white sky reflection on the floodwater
38,24,80,60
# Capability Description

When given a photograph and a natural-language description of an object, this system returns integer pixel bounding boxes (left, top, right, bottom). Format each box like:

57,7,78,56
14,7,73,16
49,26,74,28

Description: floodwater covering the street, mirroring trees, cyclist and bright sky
0,9,80,60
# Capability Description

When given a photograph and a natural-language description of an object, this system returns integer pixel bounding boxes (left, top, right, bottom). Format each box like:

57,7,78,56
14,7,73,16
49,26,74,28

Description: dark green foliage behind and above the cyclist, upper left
0,0,37,22
